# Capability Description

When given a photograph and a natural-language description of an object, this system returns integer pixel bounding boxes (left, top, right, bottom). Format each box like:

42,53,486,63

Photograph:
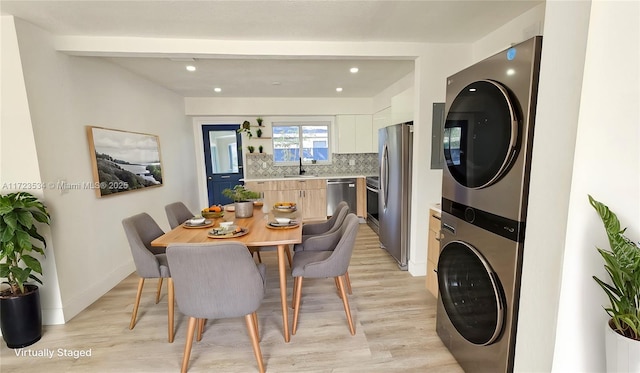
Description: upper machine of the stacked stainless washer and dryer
442,36,542,222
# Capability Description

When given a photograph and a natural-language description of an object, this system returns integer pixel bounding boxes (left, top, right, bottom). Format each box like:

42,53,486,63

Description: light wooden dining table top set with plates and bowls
151,208,302,247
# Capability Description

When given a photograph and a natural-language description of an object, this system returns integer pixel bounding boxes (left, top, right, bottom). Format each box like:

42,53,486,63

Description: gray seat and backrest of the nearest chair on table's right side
294,213,360,277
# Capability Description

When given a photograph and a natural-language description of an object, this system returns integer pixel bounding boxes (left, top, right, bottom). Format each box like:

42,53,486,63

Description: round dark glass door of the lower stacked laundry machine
438,241,505,345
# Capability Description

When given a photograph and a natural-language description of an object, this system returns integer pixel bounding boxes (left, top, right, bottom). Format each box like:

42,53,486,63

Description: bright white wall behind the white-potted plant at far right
553,0,640,372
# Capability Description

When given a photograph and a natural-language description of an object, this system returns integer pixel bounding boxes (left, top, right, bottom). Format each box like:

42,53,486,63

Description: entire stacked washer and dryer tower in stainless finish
436,36,542,373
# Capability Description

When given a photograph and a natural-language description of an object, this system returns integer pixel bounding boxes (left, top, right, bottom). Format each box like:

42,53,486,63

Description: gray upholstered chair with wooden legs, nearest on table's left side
122,213,174,342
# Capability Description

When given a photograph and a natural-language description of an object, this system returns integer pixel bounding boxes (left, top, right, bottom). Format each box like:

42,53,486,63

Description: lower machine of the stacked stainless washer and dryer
436,206,522,373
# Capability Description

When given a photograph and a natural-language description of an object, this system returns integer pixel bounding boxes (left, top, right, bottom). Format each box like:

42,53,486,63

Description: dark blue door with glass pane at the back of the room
202,124,243,206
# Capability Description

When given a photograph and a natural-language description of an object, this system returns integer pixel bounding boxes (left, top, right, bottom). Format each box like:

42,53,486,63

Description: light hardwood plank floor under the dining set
0,224,462,373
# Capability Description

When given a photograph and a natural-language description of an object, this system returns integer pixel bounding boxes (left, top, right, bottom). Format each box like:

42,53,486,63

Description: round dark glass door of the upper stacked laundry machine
443,80,518,189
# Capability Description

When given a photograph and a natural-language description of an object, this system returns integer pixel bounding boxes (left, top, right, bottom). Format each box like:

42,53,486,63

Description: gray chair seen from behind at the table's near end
167,242,266,372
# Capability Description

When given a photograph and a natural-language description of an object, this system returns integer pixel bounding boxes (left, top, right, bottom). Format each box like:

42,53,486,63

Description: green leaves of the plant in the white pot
589,196,640,340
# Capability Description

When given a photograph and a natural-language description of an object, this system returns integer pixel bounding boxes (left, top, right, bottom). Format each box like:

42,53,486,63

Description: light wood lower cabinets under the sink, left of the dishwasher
245,179,327,221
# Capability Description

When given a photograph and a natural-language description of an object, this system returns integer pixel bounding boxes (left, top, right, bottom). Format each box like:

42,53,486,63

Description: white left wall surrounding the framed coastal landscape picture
9,20,198,320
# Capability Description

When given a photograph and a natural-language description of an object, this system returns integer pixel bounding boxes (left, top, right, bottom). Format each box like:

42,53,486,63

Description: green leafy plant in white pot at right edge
589,196,640,372
